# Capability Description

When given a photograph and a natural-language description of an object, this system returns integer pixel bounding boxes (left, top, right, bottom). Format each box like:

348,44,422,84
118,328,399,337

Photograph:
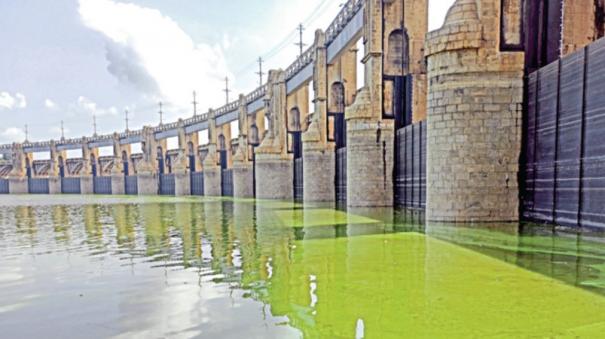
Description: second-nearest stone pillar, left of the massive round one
345,0,394,207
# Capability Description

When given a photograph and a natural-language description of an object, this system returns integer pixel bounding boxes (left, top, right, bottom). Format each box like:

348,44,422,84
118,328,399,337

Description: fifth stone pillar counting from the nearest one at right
233,95,254,198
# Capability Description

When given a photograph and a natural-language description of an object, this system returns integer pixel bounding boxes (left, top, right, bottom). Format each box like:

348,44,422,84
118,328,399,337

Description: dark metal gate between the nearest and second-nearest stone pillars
395,122,427,208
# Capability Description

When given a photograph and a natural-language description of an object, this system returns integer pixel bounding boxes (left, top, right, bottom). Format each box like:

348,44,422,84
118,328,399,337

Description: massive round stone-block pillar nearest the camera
426,0,524,222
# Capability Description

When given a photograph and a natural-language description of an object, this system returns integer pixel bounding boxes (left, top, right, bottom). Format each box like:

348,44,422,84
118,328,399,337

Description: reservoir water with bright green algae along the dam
0,196,605,338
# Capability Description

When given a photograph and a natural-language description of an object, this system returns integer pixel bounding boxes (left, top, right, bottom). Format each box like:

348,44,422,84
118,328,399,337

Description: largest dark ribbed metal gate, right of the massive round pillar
522,39,605,228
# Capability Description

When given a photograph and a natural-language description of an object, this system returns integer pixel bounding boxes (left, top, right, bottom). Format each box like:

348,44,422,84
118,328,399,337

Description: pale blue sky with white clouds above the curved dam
0,0,454,143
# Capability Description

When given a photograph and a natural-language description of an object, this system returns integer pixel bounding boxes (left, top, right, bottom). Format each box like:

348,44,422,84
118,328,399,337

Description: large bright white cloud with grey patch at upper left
79,0,231,108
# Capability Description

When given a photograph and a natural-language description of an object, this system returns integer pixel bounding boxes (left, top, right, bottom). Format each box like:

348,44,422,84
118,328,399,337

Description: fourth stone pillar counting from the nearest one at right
255,70,294,199
